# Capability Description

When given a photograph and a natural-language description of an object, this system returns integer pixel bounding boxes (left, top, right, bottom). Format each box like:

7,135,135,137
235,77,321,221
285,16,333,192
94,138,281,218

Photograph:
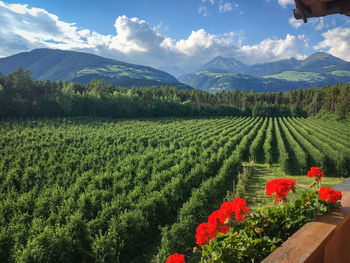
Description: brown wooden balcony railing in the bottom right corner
262,178,350,263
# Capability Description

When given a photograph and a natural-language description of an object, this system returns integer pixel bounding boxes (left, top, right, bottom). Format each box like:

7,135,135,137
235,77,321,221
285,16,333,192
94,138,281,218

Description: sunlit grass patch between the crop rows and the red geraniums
241,163,345,211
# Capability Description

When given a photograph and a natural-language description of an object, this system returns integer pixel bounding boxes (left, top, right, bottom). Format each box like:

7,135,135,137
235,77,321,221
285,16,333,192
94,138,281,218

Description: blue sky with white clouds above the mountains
0,0,350,74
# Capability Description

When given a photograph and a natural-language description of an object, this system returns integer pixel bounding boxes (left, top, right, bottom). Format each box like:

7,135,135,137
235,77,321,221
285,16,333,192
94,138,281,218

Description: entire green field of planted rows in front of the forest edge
0,117,350,262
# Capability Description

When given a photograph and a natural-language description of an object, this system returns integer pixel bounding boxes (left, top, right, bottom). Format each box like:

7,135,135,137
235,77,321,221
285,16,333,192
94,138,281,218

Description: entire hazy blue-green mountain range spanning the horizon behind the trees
0,49,350,93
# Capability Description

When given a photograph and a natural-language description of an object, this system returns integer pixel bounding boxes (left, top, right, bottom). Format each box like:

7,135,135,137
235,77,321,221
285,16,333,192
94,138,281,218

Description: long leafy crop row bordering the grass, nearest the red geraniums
159,119,262,259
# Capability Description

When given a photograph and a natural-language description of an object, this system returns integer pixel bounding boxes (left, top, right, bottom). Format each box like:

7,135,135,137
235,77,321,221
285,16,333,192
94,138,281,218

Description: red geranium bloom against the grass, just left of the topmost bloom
266,178,296,202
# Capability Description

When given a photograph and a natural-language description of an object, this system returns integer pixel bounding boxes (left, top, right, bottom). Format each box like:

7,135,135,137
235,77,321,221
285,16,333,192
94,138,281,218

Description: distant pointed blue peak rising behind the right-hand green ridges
199,56,248,72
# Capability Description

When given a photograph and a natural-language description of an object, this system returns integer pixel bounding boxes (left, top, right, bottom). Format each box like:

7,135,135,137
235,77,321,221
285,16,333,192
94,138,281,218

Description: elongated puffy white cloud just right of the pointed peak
237,34,308,64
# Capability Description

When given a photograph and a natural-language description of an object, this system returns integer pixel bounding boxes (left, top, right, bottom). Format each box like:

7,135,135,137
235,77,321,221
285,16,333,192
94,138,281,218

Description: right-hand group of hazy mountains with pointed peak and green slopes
178,52,350,92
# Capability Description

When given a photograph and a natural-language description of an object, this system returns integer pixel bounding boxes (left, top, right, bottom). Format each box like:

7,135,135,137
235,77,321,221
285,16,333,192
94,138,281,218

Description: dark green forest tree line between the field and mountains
0,69,350,119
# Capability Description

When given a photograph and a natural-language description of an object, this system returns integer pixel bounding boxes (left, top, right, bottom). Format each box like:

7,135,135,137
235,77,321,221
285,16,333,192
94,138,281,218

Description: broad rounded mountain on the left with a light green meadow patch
0,49,189,88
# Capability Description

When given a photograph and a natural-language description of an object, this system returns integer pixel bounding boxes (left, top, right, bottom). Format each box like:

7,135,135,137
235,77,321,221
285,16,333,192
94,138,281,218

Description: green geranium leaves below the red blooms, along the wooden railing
201,192,339,263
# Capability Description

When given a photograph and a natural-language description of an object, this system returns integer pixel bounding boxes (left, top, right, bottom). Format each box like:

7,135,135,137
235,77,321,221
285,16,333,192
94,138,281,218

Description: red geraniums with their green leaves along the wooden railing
170,167,342,263
